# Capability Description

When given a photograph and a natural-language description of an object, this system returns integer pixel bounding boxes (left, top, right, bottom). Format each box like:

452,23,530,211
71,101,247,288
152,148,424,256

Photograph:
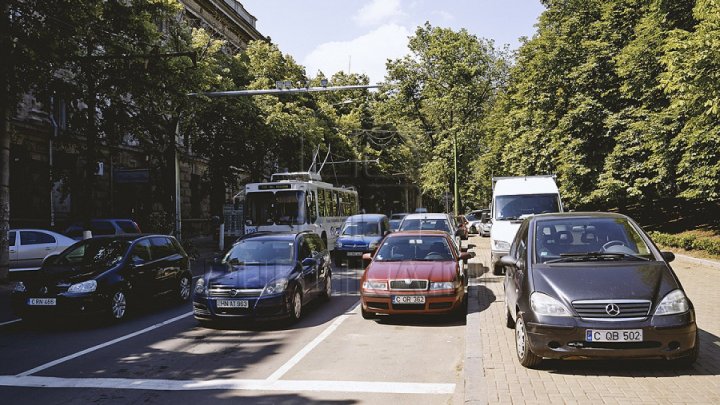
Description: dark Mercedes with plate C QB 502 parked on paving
500,213,700,368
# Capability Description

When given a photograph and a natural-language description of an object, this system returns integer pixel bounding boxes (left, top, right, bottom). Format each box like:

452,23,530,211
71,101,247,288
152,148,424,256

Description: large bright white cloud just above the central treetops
303,24,412,84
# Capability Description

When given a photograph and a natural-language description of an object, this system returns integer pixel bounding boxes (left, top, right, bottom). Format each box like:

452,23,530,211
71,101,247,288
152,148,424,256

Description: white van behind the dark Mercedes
490,175,563,275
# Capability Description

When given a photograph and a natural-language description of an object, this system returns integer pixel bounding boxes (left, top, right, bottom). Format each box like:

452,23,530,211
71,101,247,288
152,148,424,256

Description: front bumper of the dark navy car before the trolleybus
193,294,290,321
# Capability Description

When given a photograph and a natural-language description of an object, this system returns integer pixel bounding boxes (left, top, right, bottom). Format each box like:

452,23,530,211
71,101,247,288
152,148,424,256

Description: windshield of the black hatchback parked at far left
57,238,131,268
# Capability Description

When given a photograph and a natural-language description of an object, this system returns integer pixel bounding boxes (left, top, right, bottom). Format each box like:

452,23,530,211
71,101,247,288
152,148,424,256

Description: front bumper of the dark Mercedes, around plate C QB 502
527,313,699,360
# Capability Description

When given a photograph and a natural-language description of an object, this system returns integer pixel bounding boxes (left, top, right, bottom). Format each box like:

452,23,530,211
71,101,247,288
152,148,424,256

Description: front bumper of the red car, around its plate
361,288,464,315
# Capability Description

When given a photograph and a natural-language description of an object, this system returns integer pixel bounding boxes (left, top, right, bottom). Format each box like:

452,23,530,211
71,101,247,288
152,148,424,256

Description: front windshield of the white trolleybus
245,190,305,226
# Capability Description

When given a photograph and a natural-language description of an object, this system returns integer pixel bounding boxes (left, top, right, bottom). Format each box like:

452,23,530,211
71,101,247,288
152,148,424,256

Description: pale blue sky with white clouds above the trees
240,0,544,83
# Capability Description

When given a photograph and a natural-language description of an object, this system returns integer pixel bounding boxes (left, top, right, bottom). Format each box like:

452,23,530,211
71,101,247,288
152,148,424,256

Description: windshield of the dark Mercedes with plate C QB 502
535,218,652,263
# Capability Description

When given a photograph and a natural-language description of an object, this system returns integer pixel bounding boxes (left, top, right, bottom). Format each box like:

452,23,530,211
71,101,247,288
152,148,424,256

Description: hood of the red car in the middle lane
365,261,458,281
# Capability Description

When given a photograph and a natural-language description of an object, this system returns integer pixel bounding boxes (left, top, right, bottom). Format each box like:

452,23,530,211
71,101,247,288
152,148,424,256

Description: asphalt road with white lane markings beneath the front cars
0,256,465,405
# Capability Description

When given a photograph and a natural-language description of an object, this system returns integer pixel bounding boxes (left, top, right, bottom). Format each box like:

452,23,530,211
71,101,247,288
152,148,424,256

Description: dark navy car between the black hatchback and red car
193,231,332,323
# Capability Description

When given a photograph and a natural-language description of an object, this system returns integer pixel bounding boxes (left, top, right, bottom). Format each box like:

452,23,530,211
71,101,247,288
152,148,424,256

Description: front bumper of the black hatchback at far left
10,293,110,318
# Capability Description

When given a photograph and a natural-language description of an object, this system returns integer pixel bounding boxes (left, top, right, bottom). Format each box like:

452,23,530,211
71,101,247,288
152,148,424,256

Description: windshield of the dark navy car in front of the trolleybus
222,239,294,265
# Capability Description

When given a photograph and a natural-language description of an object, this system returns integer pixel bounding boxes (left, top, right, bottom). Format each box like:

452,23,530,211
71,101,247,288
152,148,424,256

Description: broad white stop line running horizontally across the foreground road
0,375,455,394
